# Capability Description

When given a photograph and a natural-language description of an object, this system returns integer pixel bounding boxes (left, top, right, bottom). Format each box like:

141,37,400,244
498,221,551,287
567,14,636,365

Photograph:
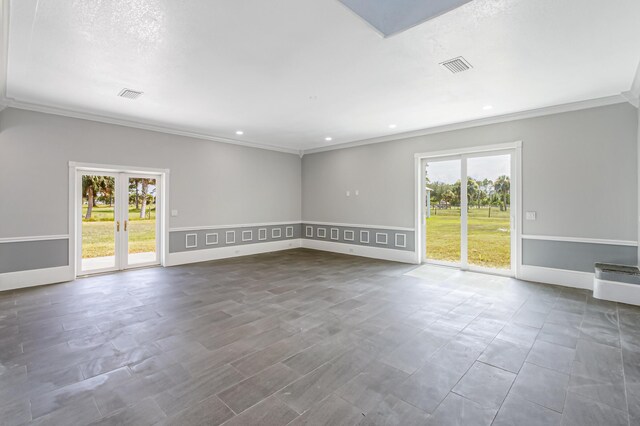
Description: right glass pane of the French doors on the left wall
125,176,158,266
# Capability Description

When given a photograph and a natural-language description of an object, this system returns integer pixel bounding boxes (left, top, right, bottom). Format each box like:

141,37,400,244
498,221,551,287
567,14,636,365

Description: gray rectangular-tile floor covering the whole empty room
0,249,640,426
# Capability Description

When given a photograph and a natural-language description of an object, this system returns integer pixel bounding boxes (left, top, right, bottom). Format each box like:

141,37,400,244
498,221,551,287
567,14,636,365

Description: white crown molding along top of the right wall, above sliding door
303,94,627,155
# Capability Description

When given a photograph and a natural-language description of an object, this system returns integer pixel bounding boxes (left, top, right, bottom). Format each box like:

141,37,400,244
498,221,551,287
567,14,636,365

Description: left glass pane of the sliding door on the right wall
425,159,462,264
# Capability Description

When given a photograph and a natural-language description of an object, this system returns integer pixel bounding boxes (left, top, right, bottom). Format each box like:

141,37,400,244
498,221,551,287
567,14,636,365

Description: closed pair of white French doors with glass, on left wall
76,170,162,275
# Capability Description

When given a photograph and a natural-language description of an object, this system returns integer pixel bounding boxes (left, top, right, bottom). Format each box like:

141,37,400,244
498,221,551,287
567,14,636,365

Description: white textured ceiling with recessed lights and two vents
7,0,640,150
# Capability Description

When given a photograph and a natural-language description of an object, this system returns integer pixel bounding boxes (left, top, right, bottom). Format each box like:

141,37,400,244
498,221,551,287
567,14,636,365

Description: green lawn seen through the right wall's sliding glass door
427,207,511,269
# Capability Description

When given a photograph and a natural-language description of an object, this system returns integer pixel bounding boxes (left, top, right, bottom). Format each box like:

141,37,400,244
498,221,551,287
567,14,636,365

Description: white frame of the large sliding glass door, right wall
414,141,522,277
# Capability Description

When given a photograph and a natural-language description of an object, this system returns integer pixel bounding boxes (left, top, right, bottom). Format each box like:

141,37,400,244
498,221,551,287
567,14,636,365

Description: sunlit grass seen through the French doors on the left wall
82,206,156,259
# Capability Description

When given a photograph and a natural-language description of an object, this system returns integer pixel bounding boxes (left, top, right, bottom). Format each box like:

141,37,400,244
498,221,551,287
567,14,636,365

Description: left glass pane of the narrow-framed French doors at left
80,174,118,272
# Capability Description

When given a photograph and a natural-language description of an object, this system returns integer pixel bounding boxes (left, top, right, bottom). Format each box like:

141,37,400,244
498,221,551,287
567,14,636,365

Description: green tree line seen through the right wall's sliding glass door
427,175,511,211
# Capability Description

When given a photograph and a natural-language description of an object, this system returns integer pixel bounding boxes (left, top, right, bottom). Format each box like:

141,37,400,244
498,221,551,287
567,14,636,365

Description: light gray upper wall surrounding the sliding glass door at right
302,103,638,241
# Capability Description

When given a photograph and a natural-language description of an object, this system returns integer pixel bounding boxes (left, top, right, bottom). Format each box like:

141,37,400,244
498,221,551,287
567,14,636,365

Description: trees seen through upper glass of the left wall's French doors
82,175,155,219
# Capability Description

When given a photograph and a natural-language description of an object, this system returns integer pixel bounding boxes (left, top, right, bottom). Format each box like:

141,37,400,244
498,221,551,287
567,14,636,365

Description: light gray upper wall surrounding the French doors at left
0,108,301,238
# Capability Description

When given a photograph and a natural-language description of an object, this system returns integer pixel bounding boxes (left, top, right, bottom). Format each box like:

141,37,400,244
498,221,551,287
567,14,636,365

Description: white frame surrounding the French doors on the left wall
69,161,170,279
